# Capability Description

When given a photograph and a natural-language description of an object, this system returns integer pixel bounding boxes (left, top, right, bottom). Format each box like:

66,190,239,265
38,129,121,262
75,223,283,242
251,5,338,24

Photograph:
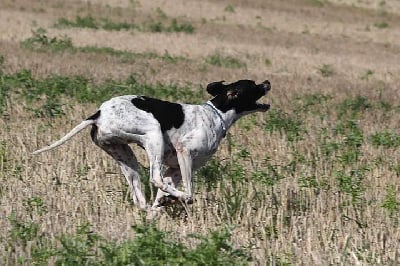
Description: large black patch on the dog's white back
132,96,185,133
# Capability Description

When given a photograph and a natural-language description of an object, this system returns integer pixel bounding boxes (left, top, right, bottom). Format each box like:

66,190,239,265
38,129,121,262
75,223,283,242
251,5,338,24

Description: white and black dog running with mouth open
33,80,271,209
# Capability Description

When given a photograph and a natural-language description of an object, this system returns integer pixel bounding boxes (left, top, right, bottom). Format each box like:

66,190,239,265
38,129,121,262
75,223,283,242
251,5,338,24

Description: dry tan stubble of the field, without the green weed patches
0,0,400,265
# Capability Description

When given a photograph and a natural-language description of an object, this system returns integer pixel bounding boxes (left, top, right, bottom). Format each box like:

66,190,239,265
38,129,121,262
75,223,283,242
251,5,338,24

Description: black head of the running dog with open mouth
207,80,271,114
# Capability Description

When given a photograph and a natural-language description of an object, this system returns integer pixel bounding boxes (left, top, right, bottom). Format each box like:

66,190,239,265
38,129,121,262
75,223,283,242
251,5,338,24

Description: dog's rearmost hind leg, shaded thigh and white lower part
96,143,147,209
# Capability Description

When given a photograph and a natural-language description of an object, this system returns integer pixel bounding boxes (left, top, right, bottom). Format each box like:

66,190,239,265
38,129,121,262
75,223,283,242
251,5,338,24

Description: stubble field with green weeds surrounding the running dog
0,0,400,265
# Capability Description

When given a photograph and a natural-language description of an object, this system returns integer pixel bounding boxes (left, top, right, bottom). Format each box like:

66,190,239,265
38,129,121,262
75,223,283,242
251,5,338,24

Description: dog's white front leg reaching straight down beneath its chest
176,147,193,204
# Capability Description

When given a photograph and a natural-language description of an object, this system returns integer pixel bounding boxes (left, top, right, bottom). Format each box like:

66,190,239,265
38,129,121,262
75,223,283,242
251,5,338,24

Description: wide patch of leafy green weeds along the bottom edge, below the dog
8,213,251,265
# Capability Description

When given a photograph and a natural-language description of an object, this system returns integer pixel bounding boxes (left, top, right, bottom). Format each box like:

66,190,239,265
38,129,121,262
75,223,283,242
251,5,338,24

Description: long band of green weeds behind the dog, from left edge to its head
0,69,203,117
